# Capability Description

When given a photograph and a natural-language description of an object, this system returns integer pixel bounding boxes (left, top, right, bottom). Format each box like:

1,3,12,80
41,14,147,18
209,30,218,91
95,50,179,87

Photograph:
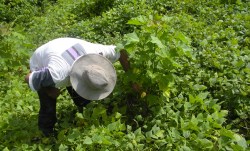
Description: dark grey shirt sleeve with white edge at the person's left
29,68,55,91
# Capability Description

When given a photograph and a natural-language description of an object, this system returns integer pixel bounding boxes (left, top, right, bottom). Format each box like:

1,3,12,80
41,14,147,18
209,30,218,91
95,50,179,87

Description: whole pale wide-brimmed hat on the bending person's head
70,54,116,100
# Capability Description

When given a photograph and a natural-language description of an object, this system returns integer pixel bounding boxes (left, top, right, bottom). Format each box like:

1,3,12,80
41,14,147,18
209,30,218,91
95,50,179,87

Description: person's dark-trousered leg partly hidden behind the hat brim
67,87,90,113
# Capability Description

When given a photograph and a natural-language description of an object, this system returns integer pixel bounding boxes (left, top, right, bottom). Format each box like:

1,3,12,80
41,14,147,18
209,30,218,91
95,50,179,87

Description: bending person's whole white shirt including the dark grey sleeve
29,38,120,91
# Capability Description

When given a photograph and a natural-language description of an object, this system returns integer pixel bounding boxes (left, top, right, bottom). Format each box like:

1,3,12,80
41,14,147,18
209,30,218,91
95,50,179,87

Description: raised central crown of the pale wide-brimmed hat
83,65,108,89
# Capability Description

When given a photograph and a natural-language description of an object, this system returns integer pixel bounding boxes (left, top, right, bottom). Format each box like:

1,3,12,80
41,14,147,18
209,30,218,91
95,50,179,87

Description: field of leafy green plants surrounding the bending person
0,0,250,151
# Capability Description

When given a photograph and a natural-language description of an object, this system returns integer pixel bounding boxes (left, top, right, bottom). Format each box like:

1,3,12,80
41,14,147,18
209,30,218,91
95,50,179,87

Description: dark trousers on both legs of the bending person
38,87,90,136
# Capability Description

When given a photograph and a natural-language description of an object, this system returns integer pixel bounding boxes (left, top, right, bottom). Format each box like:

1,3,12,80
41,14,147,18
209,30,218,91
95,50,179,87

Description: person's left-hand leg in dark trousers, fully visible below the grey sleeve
38,88,57,136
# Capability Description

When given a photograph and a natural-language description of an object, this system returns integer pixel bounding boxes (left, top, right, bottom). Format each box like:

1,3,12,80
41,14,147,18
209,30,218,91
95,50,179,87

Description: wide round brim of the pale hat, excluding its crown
70,54,117,100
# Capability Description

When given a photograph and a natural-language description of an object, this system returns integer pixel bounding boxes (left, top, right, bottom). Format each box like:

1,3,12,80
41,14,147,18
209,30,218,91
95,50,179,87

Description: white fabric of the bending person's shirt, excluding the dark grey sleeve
30,38,119,87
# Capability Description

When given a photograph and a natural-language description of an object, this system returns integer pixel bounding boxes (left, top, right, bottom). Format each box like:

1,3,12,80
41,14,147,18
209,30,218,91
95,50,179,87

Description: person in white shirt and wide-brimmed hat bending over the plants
25,38,134,136
